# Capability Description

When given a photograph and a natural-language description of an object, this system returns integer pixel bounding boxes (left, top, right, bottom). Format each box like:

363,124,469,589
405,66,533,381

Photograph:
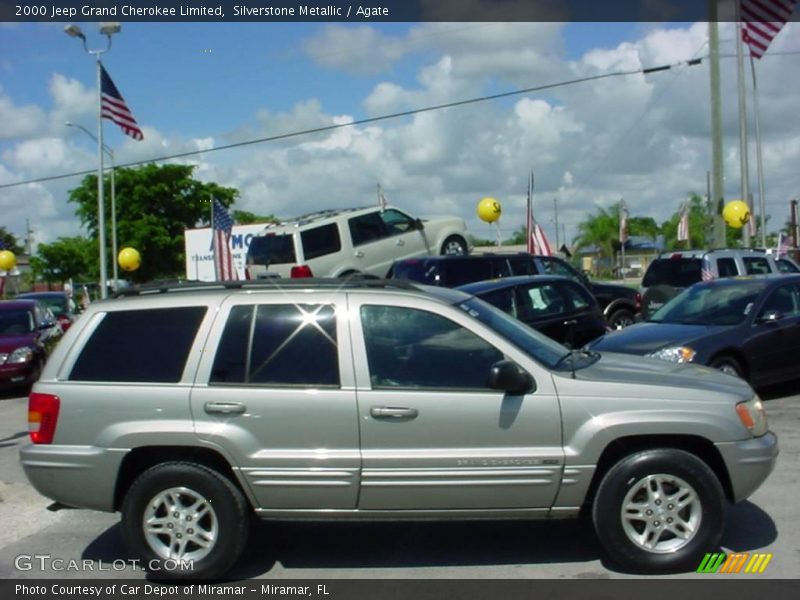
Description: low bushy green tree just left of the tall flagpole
31,237,97,283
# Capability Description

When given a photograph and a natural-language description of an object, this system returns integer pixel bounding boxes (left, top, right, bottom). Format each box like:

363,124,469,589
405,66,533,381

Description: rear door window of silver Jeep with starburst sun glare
211,304,339,387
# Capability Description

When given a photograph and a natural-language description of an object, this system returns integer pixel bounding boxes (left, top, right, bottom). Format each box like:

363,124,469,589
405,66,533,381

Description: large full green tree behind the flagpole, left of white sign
69,164,239,281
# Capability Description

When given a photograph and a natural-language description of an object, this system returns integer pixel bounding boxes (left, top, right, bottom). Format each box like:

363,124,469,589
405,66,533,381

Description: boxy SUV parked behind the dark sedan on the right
641,249,780,320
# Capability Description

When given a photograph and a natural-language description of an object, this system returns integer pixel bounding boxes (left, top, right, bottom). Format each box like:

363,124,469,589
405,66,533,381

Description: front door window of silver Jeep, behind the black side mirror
361,306,503,391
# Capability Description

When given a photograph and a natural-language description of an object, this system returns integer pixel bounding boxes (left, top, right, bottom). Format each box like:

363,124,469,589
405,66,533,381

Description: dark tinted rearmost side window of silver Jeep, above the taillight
69,306,206,383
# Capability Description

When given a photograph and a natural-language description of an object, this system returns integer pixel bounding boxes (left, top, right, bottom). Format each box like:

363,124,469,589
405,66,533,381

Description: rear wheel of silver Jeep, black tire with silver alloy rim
122,462,249,579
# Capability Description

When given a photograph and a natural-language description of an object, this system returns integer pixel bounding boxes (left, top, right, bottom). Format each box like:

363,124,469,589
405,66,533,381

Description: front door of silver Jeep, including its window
351,303,563,510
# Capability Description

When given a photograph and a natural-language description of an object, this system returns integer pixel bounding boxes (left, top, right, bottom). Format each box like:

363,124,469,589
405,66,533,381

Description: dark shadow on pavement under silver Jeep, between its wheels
230,519,601,579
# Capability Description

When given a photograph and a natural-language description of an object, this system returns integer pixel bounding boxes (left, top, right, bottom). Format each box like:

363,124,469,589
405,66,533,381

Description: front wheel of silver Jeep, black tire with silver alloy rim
592,448,725,573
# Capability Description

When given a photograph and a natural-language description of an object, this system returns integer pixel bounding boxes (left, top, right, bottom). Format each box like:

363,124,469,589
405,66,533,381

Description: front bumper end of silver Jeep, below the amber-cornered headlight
716,431,779,502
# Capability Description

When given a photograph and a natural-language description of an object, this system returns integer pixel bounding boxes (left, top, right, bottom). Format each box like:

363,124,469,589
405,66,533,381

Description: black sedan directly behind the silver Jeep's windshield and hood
456,275,608,348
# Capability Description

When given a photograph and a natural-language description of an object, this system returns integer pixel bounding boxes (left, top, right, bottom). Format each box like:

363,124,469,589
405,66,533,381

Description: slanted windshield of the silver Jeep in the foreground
456,298,570,369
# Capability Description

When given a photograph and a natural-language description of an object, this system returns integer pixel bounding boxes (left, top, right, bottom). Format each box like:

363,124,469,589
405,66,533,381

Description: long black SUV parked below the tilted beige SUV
389,253,641,329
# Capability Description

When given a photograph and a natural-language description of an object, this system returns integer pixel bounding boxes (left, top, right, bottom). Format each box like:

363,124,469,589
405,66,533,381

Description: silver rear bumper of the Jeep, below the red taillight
19,444,127,512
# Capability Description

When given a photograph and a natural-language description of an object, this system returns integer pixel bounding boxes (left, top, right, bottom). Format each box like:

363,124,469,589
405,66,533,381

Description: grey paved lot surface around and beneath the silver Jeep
0,382,800,579
